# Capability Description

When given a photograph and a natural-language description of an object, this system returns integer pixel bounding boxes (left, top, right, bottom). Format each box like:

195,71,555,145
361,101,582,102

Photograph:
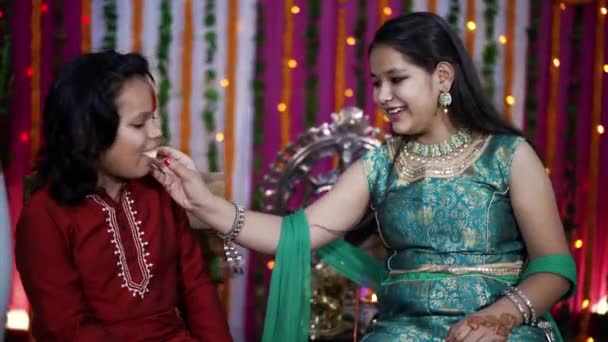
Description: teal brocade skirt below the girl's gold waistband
361,273,546,342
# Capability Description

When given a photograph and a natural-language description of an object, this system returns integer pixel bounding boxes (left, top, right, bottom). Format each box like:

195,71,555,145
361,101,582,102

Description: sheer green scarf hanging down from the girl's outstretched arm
262,210,311,342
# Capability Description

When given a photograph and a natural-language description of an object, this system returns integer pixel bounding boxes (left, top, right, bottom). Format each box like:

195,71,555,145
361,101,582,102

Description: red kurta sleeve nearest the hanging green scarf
173,199,232,342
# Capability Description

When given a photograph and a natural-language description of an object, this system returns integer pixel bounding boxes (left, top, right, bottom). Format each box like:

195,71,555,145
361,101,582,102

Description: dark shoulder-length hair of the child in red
34,51,152,205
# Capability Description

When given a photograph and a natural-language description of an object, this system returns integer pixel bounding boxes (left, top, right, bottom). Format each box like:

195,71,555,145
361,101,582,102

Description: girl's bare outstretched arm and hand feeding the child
153,147,370,254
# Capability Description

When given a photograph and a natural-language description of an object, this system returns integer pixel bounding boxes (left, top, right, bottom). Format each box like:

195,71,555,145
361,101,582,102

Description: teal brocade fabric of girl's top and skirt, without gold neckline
362,135,560,342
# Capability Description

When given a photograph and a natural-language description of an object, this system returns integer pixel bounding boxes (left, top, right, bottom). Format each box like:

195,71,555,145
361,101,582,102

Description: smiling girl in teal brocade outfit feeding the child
154,13,576,342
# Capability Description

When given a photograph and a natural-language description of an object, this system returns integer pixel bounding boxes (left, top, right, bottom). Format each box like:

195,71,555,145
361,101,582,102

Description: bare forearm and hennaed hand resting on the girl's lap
487,273,570,325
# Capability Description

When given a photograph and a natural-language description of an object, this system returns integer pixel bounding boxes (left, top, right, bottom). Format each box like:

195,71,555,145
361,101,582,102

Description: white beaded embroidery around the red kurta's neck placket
87,191,153,298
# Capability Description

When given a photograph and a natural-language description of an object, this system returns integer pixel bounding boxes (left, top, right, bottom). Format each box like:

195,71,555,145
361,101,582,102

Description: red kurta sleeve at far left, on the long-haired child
15,201,117,342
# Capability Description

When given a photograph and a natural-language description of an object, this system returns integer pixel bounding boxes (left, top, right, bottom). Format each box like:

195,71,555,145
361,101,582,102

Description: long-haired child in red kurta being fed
16,52,232,342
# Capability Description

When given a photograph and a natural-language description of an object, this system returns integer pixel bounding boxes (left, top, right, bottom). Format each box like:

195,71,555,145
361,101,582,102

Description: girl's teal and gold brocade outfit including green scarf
264,135,575,342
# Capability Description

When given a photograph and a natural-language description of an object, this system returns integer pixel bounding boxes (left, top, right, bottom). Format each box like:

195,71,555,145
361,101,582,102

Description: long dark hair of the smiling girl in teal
368,12,524,207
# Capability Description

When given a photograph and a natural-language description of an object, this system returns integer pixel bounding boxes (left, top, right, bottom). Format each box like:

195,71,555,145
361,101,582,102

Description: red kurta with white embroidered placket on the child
15,178,232,342
